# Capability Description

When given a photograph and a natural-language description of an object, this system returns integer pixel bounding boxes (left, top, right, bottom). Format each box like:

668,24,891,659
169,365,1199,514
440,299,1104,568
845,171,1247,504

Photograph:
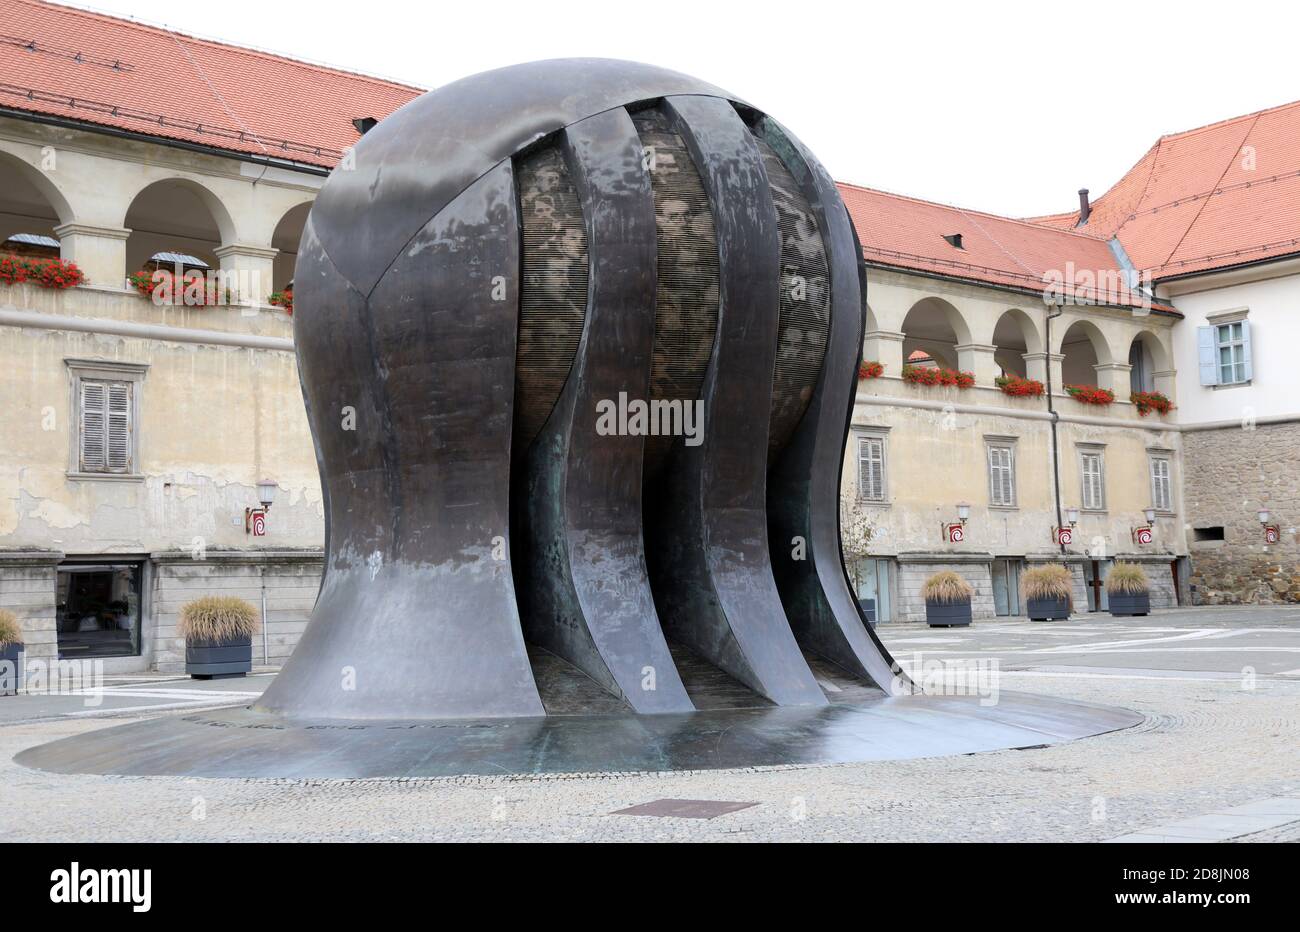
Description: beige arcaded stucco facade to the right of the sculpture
842,269,1187,620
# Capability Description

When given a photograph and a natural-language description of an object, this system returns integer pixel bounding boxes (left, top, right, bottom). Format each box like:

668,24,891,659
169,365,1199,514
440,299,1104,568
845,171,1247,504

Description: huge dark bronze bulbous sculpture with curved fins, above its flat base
259,60,893,720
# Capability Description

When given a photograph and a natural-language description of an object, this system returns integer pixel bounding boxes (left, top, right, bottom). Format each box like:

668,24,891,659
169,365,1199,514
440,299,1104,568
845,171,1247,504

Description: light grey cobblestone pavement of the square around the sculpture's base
0,610,1300,841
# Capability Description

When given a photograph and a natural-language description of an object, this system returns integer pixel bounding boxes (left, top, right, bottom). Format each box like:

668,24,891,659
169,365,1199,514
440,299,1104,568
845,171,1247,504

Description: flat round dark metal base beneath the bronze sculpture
16,692,1143,780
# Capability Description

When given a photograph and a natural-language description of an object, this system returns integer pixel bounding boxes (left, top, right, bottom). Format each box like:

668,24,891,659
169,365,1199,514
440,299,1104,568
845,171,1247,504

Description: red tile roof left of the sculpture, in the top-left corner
0,0,423,168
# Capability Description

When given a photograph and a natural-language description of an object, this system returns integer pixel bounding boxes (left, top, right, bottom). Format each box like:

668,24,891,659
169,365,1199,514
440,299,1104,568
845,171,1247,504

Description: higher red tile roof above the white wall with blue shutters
1032,101,1300,279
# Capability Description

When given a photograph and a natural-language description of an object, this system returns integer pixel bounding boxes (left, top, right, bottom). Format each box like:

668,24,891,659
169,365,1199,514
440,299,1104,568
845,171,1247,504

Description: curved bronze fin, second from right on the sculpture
646,96,826,706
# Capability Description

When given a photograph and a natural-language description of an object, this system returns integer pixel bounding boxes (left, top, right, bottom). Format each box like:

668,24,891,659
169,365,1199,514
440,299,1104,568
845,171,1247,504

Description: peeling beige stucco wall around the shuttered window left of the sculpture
0,285,324,555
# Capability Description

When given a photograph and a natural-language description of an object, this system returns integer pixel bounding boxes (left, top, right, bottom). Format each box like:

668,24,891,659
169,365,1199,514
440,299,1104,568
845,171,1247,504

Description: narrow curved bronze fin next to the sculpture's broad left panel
521,109,694,712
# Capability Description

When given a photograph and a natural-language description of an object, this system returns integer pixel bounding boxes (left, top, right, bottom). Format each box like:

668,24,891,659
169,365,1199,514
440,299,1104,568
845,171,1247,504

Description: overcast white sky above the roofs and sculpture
65,0,1300,216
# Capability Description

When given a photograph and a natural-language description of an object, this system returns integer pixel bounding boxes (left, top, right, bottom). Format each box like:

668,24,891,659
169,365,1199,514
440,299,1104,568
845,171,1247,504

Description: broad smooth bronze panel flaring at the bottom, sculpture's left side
259,162,543,719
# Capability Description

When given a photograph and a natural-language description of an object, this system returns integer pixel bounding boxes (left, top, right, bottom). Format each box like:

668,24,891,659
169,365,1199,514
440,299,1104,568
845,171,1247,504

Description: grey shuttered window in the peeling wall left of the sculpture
66,359,147,481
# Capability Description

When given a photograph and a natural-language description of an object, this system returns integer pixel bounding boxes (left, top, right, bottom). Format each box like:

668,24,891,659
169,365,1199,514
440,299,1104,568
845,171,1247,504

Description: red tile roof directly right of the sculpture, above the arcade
839,183,1171,311
